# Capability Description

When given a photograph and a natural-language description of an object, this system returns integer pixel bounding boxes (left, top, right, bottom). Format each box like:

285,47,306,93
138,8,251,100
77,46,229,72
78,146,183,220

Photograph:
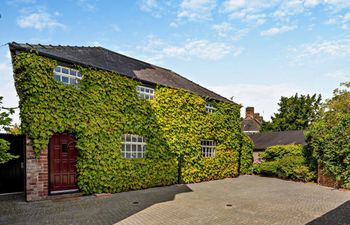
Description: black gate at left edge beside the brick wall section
0,134,25,194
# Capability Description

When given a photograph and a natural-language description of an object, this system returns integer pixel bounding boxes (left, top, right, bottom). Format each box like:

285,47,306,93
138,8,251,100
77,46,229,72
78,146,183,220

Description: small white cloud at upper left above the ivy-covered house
17,10,65,31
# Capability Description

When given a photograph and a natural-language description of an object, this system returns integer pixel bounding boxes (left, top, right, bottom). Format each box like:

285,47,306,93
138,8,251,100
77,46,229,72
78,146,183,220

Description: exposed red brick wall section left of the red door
26,138,49,201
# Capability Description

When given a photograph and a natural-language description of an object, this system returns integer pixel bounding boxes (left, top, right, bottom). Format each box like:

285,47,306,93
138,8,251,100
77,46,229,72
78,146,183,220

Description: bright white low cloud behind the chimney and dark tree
208,84,306,120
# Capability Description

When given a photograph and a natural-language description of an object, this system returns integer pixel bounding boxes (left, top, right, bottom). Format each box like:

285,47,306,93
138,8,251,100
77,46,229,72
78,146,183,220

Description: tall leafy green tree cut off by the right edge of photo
307,82,350,188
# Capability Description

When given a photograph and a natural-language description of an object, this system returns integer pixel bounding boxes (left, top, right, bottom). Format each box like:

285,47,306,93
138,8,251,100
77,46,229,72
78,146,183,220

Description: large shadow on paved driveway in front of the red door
0,185,192,225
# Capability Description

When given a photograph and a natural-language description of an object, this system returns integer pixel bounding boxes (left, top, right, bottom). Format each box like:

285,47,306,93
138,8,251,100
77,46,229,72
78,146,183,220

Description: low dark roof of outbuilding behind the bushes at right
249,130,306,151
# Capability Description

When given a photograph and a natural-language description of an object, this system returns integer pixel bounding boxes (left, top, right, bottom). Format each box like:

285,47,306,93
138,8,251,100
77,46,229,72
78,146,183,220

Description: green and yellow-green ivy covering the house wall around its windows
13,52,252,197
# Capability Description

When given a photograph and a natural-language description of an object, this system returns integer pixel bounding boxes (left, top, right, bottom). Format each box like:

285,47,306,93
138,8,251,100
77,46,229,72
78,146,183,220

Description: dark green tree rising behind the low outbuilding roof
261,93,321,131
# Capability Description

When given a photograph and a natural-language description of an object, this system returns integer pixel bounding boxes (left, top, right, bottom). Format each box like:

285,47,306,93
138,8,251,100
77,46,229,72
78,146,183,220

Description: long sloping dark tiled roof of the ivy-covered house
9,42,229,101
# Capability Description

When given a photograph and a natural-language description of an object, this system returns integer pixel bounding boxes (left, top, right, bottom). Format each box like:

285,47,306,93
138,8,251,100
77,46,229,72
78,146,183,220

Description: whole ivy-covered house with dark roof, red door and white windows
9,42,249,201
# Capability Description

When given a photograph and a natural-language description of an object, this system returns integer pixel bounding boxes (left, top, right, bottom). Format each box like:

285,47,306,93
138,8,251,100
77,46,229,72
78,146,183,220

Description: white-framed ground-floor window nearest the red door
121,134,146,159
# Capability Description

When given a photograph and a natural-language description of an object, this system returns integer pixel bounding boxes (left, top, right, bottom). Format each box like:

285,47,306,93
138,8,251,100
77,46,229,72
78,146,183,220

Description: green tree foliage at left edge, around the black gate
0,96,18,164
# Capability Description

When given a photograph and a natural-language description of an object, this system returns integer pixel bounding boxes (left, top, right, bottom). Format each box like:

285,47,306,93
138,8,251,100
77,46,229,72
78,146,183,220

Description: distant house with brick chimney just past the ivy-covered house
241,107,263,134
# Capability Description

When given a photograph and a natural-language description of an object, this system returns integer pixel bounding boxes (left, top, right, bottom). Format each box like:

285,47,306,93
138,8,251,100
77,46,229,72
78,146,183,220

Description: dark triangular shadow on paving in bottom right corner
307,201,350,225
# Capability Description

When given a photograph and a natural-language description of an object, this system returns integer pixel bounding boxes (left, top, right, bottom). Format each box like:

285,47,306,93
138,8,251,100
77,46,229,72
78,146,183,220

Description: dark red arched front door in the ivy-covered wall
50,133,78,192
